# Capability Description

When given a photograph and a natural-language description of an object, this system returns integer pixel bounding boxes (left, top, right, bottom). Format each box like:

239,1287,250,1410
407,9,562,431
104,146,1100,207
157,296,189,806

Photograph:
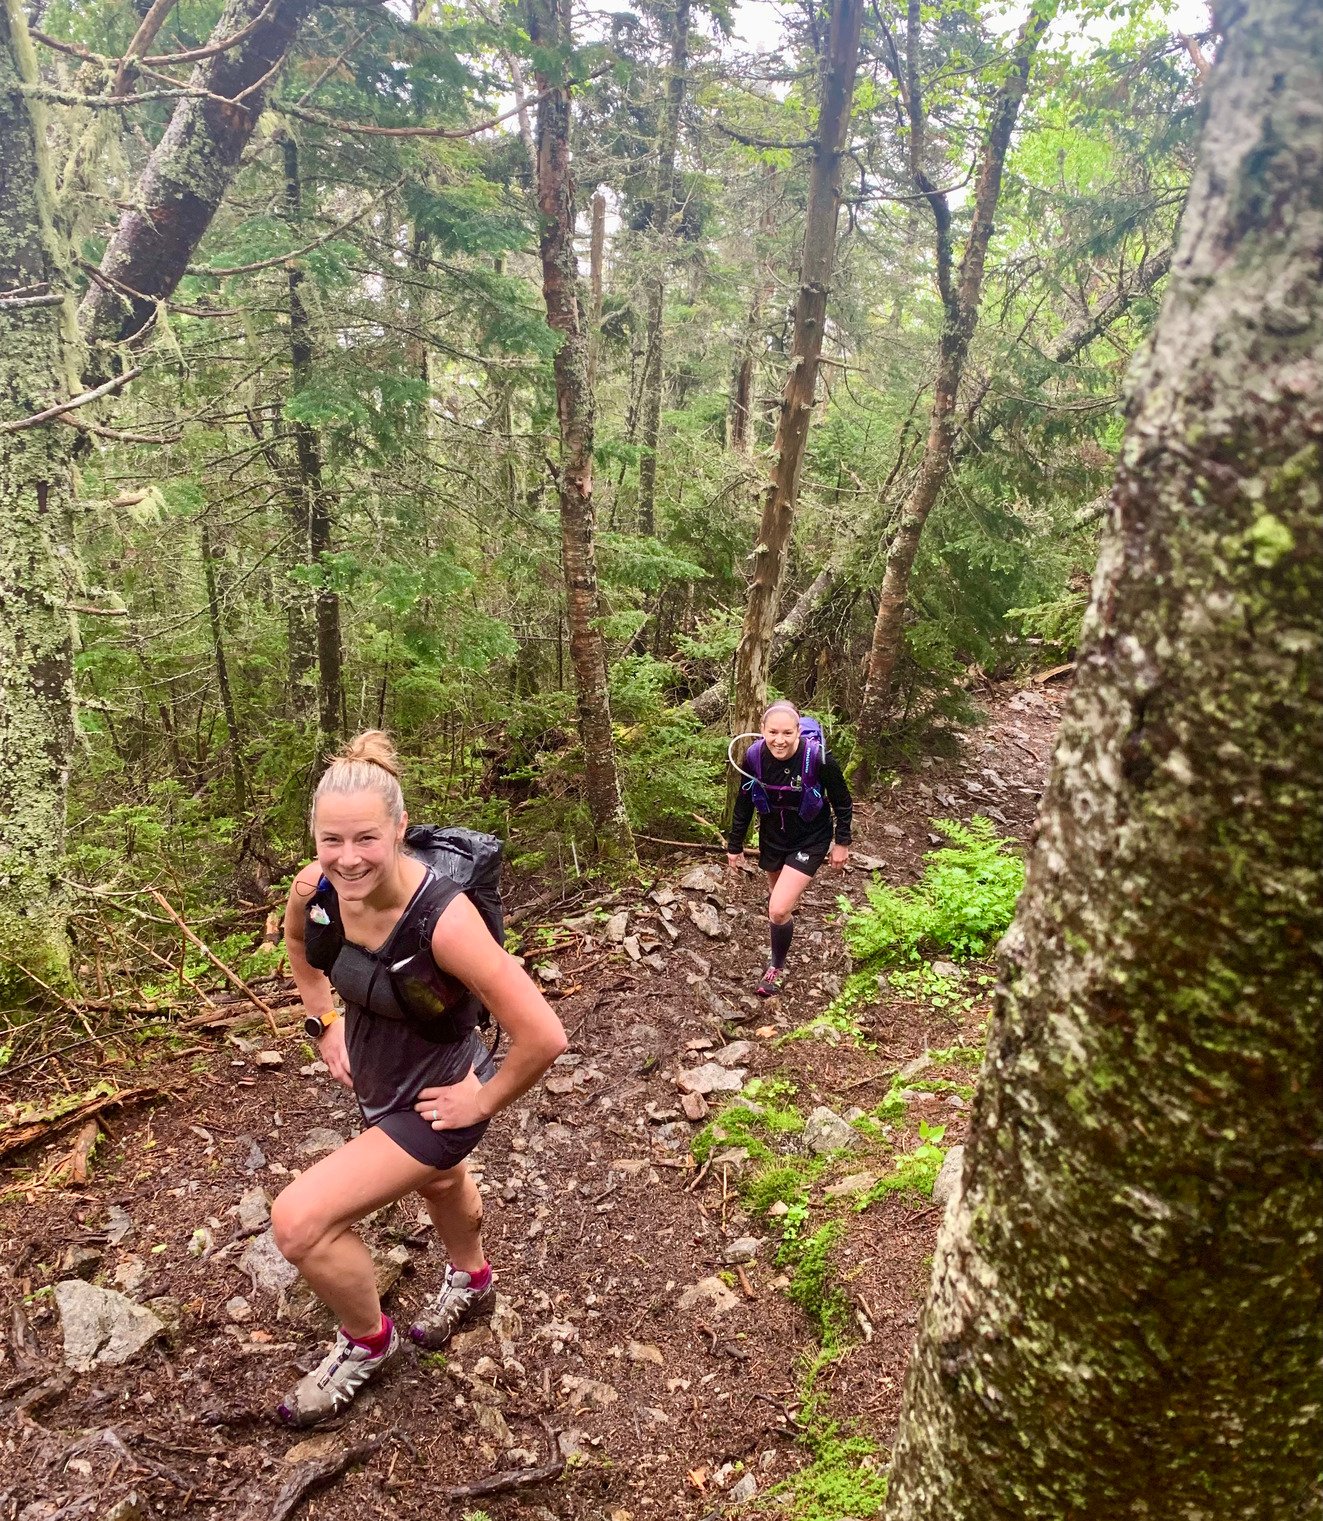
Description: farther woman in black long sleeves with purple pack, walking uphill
725,701,855,998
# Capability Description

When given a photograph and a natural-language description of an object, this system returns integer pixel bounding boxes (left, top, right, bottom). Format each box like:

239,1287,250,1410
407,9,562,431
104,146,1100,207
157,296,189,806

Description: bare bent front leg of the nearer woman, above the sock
271,1127,438,1337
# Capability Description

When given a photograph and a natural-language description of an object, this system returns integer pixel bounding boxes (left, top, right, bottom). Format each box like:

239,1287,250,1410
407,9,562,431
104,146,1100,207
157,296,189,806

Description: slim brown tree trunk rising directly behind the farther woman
734,0,862,754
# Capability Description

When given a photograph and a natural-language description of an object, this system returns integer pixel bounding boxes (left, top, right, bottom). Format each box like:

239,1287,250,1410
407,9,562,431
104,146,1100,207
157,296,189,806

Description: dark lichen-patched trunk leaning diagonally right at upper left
79,0,316,358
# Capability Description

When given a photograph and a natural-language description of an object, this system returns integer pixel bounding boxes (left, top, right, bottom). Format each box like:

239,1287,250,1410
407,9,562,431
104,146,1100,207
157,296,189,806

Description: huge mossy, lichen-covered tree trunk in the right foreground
887,0,1323,1521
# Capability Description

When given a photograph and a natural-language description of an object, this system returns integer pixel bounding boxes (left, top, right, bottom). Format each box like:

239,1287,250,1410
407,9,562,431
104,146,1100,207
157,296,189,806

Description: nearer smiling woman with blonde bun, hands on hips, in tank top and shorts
271,729,566,1427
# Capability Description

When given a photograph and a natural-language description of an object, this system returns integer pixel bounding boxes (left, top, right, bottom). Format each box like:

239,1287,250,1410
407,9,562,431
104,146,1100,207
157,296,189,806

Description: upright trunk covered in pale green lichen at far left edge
0,0,81,1005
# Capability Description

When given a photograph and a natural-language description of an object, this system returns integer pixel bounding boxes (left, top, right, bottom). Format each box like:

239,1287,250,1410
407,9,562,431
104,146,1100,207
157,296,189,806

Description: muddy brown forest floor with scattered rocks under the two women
0,683,1064,1521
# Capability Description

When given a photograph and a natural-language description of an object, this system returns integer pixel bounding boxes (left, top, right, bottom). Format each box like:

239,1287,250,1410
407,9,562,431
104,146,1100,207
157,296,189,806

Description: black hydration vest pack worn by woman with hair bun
304,824,505,1045
